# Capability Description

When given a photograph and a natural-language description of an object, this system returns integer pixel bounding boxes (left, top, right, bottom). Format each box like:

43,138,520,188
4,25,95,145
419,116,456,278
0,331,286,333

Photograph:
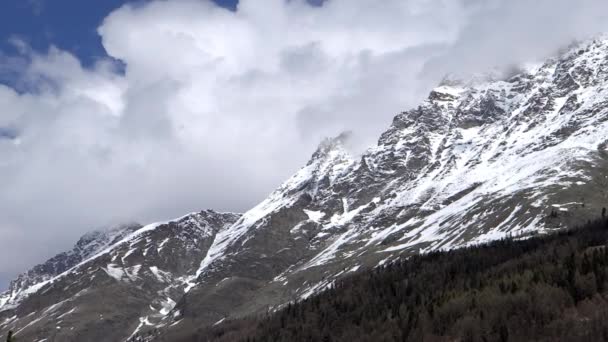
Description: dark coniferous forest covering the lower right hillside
180,219,608,342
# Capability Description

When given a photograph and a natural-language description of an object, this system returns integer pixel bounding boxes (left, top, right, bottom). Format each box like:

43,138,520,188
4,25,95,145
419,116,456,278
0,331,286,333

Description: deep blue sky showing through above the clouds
0,0,238,65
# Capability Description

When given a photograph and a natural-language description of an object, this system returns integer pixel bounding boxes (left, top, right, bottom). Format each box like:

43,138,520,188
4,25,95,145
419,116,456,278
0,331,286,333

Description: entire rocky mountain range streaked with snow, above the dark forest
0,38,608,341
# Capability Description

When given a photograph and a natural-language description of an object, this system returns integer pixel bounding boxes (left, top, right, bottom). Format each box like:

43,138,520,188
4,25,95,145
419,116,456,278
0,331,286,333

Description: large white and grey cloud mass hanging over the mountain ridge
0,0,608,284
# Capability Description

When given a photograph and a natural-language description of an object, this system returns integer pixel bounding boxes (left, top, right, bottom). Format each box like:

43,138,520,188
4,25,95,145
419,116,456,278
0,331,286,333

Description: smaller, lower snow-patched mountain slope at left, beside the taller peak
0,210,239,341
